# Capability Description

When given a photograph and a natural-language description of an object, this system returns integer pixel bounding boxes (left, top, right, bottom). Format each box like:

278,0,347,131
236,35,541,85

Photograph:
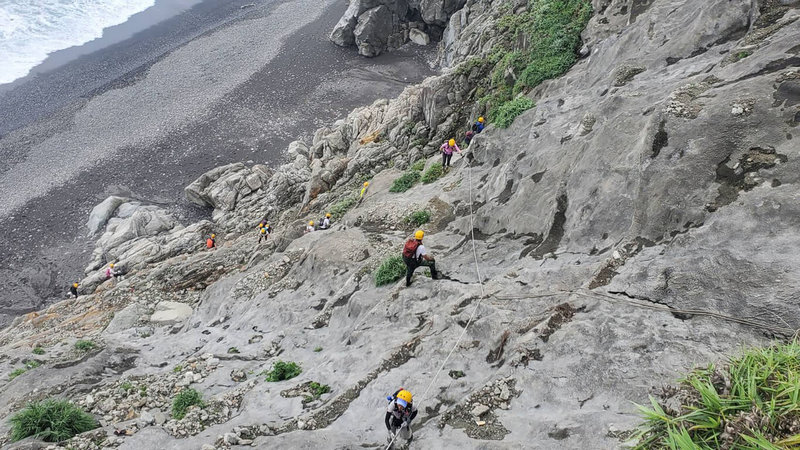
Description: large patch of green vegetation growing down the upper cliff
476,0,592,127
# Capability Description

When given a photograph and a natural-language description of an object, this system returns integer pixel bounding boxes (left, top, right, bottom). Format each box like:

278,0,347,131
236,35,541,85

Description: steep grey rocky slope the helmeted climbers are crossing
0,0,800,449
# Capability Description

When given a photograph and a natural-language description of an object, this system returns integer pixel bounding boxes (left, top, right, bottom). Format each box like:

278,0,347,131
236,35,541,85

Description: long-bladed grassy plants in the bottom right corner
636,341,800,450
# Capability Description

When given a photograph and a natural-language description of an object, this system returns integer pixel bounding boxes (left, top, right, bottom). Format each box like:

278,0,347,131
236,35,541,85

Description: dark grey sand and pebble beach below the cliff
0,0,438,324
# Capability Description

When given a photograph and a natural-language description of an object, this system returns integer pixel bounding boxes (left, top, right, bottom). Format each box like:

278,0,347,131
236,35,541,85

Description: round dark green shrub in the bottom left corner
11,399,97,442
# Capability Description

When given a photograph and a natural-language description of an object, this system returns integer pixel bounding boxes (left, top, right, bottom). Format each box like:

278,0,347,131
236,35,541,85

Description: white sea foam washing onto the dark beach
0,0,155,84
